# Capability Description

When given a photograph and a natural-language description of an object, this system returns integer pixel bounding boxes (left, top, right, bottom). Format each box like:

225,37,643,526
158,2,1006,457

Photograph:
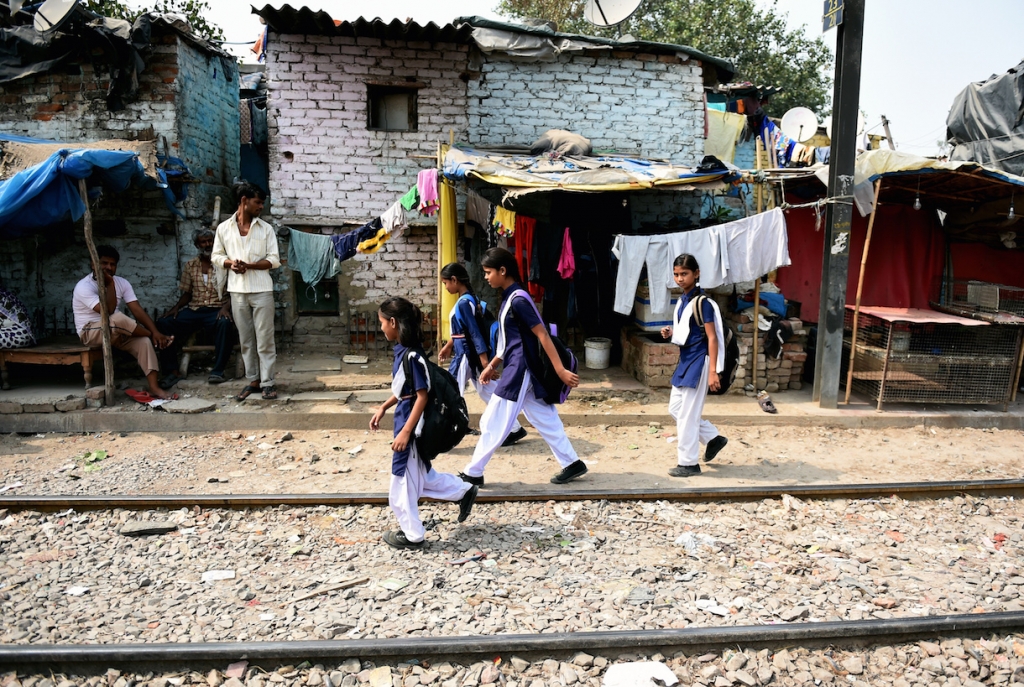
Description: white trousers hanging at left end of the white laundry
613,235,675,319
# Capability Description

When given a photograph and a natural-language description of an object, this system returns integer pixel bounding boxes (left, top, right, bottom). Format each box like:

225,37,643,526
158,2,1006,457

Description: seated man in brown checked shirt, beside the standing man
157,229,234,389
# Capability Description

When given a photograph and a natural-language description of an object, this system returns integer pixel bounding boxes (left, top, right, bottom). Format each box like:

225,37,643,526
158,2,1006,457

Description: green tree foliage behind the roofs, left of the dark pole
498,0,833,116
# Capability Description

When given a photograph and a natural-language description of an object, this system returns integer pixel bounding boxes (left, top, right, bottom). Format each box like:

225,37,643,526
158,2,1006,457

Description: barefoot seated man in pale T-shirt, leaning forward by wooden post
72,246,174,398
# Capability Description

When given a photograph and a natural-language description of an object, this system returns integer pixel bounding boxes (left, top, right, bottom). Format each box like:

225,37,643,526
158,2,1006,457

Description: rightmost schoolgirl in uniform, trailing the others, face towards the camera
662,253,729,477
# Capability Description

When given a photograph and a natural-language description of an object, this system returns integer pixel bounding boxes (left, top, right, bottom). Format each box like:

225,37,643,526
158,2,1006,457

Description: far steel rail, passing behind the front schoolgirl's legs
0,479,1024,511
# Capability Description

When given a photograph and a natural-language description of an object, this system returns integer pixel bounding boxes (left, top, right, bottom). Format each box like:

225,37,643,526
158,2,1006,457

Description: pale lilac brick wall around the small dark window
266,35,468,226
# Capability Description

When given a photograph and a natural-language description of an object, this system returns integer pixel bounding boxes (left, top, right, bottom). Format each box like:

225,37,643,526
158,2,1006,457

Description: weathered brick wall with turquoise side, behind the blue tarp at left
0,32,239,333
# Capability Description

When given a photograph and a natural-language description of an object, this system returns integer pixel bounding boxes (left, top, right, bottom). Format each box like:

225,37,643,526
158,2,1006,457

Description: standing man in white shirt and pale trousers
212,181,281,400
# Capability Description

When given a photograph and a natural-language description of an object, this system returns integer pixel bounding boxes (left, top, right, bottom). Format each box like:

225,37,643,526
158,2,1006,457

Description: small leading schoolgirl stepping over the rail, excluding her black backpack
370,297,477,549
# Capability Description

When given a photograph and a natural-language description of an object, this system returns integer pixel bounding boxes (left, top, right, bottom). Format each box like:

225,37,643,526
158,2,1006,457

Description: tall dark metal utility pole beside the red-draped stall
813,0,864,409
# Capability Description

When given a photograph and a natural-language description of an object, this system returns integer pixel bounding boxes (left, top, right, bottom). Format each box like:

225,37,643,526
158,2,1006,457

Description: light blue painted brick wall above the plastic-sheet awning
468,50,703,166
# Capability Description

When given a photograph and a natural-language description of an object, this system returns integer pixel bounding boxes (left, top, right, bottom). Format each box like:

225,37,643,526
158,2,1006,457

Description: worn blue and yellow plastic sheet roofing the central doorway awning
443,147,738,191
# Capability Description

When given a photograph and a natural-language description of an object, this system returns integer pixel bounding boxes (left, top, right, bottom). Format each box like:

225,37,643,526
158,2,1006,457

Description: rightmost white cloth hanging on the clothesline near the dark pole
716,208,791,284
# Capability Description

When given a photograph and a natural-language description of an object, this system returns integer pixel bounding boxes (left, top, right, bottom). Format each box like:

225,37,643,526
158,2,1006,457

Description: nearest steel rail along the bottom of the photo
0,611,1024,669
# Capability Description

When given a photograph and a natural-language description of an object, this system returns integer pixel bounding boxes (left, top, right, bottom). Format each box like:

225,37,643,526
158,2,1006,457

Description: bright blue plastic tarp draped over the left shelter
0,149,146,239
